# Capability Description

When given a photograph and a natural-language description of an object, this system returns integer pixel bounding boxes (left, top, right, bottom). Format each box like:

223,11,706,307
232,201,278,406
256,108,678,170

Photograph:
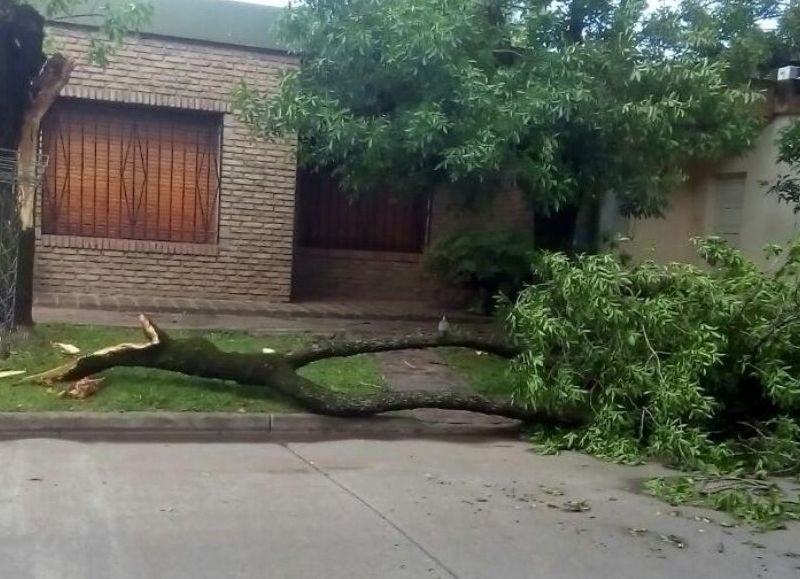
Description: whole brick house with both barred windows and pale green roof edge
35,0,530,302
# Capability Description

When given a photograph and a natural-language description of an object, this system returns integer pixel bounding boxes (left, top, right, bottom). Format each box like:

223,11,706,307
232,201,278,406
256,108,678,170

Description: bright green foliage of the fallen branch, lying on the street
507,238,800,474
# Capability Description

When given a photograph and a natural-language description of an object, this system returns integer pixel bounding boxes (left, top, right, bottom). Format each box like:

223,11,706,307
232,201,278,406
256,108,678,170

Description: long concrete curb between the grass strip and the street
0,412,518,439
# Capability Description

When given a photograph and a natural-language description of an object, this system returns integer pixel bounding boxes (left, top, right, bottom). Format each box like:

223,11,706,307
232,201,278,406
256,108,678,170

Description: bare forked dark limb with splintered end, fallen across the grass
30,316,585,426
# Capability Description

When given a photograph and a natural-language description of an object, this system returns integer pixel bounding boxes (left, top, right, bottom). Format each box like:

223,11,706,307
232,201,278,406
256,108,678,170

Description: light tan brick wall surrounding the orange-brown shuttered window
35,26,295,301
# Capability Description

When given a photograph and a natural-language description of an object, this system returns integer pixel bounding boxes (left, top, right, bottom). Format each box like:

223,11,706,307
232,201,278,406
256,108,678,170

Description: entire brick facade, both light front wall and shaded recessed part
35,26,531,302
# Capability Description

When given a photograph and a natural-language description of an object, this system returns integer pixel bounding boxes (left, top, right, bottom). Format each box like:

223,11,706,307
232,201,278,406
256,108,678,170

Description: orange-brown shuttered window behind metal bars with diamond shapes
42,100,222,243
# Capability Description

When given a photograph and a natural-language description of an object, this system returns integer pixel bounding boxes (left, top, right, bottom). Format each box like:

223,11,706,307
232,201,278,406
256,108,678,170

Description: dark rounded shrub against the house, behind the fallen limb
422,231,533,313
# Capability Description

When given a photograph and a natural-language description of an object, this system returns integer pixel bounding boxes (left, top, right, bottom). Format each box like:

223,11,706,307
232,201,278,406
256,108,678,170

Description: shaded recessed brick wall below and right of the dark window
294,190,533,305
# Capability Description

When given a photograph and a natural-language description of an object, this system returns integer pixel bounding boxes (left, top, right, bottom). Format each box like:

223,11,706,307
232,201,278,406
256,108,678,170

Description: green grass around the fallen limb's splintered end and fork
0,325,383,412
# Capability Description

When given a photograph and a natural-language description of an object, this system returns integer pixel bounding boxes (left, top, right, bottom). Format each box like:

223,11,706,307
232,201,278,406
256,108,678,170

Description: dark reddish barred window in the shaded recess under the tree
297,165,429,253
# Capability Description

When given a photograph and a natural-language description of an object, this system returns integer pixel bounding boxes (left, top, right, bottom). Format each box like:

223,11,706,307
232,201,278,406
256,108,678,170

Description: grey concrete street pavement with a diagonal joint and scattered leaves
0,439,800,579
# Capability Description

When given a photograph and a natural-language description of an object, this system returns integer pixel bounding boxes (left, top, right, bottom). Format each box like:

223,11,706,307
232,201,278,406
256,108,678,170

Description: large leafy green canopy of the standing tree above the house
236,0,797,220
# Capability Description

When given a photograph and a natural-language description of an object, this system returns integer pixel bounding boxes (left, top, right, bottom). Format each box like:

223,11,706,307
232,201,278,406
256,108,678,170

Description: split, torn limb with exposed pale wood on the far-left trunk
14,54,75,326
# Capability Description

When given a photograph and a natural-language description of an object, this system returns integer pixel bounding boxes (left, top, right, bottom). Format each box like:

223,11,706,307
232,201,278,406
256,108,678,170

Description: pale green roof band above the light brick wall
44,0,286,51
